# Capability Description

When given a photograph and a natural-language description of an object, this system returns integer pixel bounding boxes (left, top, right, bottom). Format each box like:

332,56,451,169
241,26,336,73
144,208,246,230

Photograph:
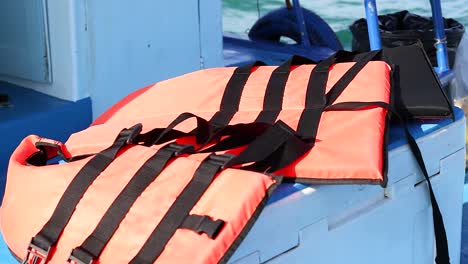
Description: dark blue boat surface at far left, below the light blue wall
0,82,91,197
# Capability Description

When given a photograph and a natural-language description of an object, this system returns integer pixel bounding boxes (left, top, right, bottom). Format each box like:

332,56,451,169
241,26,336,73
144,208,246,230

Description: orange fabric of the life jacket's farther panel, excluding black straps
81,61,391,184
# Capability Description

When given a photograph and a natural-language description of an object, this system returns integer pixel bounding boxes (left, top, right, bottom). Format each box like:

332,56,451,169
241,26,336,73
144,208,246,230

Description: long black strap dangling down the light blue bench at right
325,102,450,264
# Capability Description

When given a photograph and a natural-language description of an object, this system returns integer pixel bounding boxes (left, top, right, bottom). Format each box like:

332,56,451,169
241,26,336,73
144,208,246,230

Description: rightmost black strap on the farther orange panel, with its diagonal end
297,51,380,140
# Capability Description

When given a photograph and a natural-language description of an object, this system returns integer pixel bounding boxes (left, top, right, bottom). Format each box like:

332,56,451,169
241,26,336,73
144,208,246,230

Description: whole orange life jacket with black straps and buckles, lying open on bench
1,52,450,264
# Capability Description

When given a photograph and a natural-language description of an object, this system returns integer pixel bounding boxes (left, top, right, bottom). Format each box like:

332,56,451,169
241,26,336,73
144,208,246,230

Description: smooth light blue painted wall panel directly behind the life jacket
86,0,216,117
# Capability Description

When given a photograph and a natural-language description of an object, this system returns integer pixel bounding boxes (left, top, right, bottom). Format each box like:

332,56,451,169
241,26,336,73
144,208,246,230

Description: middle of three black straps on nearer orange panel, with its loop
68,113,216,263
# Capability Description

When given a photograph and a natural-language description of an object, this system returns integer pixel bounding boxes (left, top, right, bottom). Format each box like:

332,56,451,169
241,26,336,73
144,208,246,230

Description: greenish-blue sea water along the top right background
223,0,468,48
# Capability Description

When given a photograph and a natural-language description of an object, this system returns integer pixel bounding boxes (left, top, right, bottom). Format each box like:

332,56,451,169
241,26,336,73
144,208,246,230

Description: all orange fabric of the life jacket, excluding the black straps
1,62,391,263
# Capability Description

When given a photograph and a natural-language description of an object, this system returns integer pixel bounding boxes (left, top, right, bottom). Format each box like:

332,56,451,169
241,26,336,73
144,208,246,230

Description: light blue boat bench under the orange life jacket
229,109,465,264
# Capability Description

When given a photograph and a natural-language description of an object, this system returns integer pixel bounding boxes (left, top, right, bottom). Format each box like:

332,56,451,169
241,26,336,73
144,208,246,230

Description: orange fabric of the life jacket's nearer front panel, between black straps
1,136,275,264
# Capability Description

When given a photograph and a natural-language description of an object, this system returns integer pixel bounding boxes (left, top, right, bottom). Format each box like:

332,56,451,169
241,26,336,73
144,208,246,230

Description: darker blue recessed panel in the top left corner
0,0,51,82
